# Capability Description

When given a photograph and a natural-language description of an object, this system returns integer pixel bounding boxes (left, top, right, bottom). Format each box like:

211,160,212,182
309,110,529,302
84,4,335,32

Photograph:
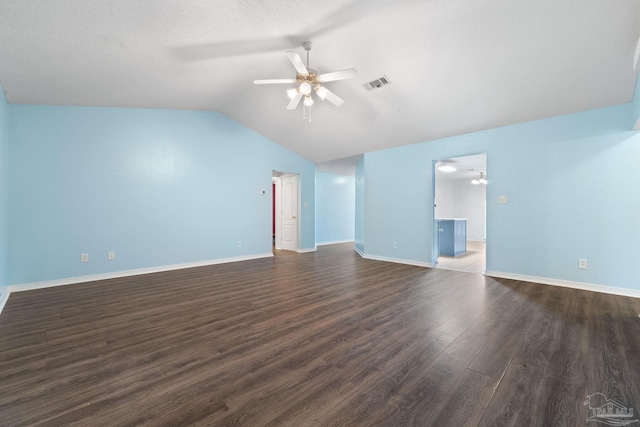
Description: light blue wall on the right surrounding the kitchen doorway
356,104,640,289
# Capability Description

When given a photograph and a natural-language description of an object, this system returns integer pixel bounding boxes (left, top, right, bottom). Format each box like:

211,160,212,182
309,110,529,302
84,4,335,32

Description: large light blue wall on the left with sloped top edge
9,105,315,284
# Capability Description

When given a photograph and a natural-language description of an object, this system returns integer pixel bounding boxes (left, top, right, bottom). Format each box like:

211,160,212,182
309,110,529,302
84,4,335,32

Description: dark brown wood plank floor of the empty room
0,244,640,426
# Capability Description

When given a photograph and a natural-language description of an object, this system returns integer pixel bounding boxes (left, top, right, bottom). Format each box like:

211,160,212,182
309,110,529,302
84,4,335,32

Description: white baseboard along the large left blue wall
7,252,273,293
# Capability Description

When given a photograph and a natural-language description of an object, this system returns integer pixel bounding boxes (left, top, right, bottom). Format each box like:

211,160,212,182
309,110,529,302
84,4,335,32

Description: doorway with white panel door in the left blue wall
271,171,299,253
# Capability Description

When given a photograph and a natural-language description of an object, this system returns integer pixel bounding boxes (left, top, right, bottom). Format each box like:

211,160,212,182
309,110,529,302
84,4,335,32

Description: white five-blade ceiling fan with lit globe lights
253,41,358,110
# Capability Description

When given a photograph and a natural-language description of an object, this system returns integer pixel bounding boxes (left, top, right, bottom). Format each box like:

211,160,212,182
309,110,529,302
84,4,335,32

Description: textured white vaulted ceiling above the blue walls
0,0,640,166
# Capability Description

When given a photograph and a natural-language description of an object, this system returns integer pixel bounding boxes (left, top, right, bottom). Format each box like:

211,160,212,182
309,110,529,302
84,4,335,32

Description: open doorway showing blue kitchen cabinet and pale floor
433,153,488,273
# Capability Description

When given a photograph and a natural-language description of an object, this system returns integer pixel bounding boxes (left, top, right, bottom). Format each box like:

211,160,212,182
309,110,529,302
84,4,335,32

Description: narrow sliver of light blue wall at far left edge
0,86,9,296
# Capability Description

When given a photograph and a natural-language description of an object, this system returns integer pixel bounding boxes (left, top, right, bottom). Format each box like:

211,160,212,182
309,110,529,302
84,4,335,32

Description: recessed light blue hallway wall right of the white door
316,171,356,243
